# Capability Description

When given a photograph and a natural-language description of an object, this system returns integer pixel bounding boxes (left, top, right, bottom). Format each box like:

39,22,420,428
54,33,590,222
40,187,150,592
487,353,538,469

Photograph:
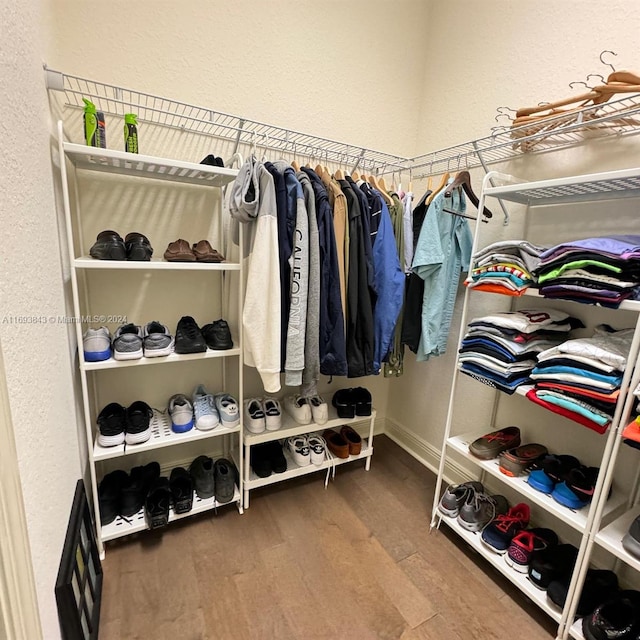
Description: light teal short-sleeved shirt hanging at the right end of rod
412,189,472,361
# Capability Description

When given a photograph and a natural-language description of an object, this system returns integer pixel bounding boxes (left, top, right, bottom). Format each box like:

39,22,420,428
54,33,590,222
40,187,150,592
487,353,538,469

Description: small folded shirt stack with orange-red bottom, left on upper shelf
465,240,546,296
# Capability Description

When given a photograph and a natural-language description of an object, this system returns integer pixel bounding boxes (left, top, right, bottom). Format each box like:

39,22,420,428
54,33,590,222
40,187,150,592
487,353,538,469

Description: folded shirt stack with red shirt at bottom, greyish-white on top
526,325,633,433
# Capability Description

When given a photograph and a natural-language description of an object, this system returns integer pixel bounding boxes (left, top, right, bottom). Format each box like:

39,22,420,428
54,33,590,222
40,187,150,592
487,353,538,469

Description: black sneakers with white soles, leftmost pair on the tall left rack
97,400,153,447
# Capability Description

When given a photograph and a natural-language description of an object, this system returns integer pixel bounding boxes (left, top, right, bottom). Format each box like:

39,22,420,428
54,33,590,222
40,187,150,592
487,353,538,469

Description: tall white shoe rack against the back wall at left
58,121,244,555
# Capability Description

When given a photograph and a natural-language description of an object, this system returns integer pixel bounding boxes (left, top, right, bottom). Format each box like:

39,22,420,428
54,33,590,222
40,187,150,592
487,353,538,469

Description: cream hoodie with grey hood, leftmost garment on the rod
229,157,280,393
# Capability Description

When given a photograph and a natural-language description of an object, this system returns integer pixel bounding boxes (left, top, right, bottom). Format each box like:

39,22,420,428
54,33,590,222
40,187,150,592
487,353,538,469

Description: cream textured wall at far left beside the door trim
0,0,80,640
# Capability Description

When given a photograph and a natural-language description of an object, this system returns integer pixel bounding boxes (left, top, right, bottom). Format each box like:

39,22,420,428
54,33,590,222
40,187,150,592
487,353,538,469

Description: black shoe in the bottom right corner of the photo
582,590,640,640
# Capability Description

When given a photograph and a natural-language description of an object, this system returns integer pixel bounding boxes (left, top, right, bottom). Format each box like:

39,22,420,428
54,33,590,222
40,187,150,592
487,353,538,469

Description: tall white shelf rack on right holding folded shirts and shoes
431,168,640,640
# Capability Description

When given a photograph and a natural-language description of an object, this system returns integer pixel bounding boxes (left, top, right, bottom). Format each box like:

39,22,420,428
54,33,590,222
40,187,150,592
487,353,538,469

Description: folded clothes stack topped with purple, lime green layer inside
535,235,640,309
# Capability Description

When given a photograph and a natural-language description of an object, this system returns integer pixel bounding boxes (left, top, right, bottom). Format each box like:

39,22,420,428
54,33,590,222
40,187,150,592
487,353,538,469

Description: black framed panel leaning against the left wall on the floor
55,480,102,640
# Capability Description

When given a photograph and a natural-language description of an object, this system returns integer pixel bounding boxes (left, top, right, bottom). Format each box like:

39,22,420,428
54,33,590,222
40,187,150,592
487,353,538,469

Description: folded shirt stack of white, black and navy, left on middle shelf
458,309,582,394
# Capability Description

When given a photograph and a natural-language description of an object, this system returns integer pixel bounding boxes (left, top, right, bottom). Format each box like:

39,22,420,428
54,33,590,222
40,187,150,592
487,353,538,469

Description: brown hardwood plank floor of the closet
100,436,556,640
